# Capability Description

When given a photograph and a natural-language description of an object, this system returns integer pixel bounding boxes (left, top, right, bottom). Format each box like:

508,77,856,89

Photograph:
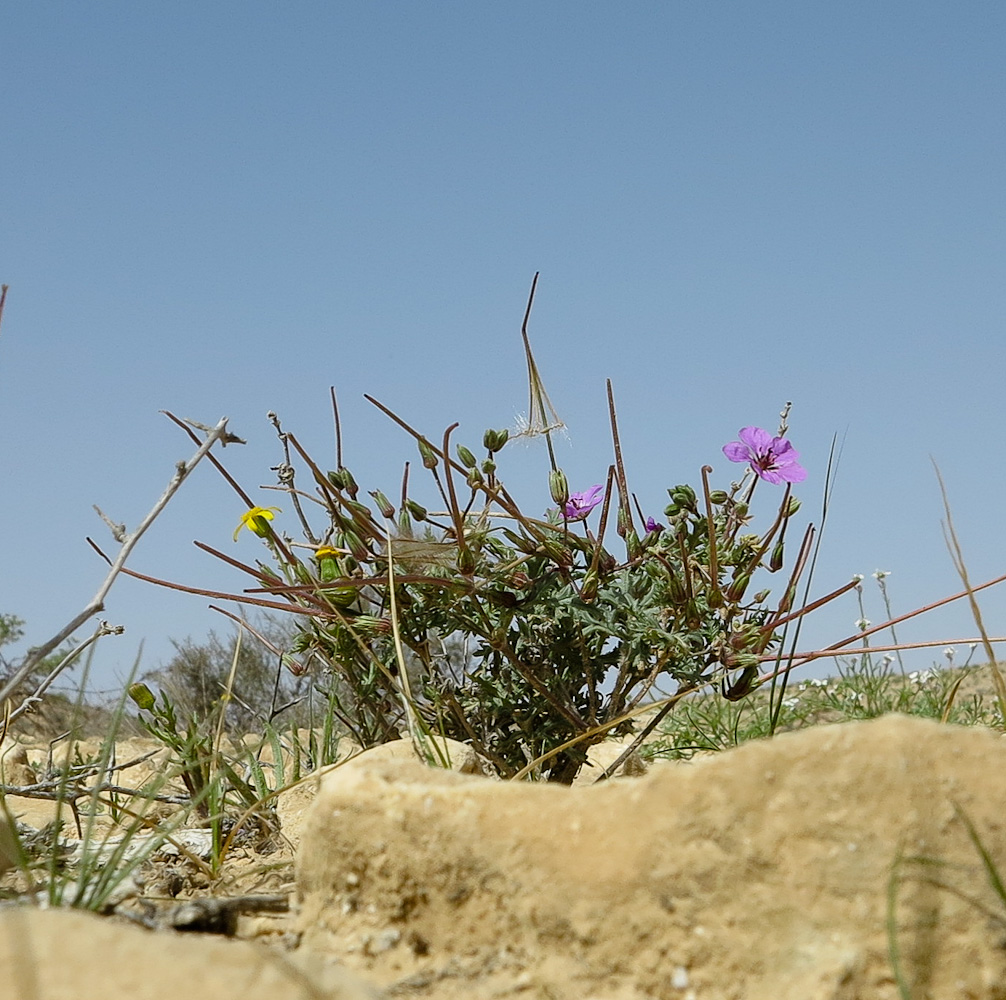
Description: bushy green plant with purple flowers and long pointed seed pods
187,281,841,782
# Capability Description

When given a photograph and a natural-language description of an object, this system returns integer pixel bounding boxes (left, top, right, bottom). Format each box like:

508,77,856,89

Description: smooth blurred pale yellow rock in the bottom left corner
0,908,378,1000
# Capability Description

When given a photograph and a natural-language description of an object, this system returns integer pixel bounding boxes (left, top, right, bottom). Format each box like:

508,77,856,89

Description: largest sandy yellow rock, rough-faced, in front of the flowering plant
298,716,1006,1000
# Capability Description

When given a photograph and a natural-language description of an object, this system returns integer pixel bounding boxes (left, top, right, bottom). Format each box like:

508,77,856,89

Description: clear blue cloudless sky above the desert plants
0,0,1006,692
